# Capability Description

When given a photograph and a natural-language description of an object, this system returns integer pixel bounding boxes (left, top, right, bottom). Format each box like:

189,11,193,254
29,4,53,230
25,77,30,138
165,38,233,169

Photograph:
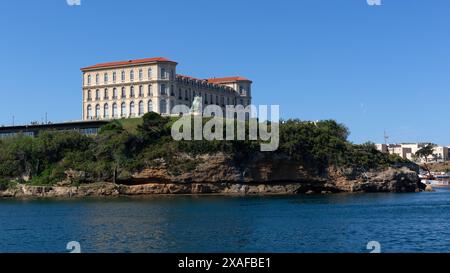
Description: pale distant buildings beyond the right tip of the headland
376,143,449,162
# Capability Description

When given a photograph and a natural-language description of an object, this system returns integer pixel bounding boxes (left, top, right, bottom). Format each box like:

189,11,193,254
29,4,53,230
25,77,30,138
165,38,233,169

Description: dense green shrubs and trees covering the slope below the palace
0,113,408,186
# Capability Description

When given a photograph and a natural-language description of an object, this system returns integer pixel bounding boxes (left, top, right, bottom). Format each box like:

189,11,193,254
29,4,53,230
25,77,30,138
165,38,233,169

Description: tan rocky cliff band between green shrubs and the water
0,154,422,197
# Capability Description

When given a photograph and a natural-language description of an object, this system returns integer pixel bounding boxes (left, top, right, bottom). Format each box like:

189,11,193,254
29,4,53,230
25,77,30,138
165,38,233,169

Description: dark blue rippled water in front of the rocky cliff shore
0,190,450,252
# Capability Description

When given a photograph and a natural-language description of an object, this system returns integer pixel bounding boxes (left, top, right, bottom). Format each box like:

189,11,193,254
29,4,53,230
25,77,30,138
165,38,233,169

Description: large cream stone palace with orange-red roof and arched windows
81,57,252,120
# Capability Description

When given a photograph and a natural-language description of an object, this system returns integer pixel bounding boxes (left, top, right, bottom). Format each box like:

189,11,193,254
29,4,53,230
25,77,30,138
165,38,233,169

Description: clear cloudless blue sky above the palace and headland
0,0,450,145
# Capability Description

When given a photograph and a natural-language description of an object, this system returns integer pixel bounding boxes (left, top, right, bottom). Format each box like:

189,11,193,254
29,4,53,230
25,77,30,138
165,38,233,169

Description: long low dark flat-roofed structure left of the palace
0,120,108,139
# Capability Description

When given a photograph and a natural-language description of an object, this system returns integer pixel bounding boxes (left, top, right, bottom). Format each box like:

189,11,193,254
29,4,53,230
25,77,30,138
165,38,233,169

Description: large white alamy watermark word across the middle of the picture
171,101,280,152
